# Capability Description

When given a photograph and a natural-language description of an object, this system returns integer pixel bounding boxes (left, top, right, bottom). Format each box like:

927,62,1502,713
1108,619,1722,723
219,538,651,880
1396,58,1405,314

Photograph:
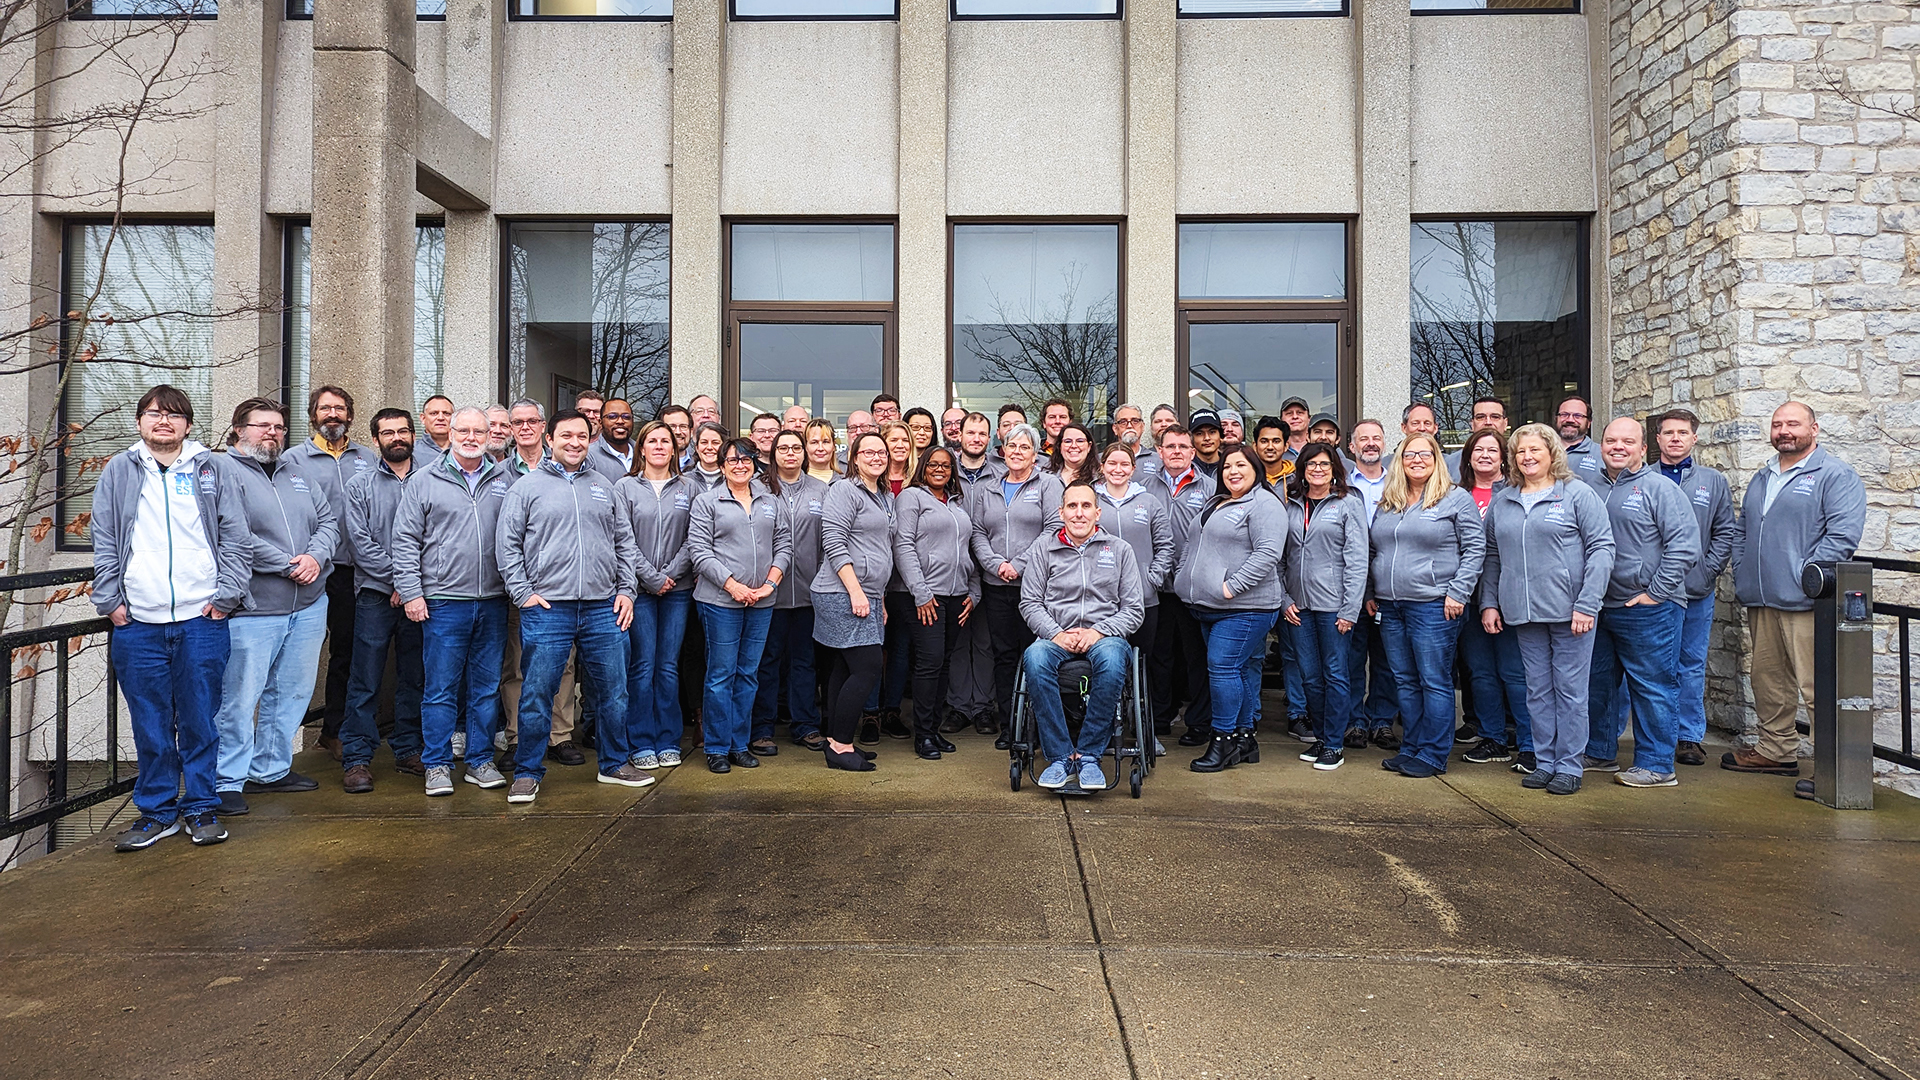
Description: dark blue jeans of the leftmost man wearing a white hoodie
111,615,230,822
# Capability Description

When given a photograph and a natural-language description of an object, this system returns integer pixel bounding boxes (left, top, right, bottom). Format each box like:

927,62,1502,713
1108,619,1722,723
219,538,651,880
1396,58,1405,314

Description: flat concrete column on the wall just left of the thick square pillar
209,0,284,401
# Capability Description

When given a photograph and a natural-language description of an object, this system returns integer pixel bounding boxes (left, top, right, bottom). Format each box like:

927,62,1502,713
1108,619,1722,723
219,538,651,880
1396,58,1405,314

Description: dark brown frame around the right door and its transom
1173,213,1359,432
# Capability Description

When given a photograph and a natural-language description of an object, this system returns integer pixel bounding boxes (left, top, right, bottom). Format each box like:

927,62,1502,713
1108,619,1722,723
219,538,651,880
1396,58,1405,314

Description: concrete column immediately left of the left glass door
672,0,726,402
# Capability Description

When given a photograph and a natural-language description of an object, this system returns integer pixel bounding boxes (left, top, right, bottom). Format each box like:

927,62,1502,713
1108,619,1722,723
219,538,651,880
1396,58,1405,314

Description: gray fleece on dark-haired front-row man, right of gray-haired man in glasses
497,459,639,607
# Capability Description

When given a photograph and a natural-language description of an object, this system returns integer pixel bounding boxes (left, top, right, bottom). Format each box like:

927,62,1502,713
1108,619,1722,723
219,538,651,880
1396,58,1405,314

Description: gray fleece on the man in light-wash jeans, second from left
215,452,340,615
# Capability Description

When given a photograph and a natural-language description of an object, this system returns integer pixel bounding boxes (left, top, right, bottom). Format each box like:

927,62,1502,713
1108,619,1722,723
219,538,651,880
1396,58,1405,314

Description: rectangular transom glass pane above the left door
730,223,893,304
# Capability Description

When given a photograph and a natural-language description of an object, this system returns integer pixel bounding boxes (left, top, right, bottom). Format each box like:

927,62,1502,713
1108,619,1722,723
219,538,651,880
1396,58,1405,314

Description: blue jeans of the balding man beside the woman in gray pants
1586,601,1686,773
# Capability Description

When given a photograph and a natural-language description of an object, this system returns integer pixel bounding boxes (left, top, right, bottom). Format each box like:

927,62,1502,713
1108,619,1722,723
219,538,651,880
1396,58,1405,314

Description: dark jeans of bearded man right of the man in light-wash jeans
340,588,426,769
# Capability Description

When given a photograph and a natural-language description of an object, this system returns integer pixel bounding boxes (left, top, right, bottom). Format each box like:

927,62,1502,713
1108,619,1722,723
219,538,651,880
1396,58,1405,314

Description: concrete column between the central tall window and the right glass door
1114,2,1181,409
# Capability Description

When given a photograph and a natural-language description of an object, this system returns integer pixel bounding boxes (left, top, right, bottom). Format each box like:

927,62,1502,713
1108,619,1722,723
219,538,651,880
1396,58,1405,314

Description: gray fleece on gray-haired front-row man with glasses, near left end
388,454,514,603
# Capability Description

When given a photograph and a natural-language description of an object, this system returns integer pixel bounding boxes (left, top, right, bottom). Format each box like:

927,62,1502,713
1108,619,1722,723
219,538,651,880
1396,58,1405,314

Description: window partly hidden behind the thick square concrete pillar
284,223,447,444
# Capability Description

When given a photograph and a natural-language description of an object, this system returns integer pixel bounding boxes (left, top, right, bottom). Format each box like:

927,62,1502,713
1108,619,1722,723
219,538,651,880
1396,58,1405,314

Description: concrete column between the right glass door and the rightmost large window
1354,0,1413,432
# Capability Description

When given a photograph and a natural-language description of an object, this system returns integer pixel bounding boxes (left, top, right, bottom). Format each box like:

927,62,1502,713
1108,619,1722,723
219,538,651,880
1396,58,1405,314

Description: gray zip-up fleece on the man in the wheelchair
1020,528,1146,638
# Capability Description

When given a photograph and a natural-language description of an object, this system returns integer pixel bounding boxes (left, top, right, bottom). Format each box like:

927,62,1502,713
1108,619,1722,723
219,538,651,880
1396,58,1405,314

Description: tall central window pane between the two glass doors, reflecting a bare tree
952,225,1119,419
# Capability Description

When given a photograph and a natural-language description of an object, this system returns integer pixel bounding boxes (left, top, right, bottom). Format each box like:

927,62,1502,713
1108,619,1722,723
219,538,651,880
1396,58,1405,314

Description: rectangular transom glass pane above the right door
1179,221,1346,300
